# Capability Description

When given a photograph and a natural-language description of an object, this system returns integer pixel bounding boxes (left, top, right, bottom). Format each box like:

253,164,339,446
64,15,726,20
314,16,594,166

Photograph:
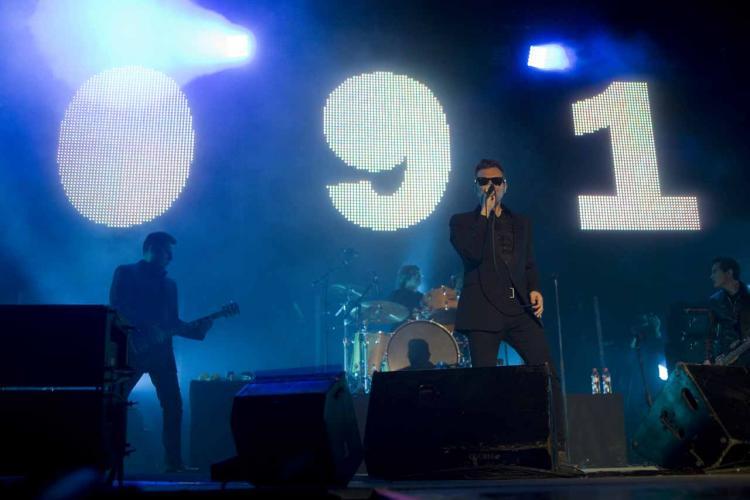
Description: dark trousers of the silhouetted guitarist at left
126,367,182,468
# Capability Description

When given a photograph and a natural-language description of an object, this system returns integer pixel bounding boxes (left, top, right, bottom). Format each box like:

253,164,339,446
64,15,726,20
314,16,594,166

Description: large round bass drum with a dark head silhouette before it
386,320,459,371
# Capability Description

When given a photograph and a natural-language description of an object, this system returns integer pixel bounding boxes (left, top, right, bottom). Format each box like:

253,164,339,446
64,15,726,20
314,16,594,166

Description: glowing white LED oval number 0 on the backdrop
57,67,195,227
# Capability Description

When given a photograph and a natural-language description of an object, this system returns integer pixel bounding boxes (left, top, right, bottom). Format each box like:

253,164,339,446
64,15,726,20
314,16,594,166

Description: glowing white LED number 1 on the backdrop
573,82,700,231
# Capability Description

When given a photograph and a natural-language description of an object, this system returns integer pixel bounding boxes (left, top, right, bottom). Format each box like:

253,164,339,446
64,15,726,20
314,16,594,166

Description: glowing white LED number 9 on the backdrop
323,72,451,231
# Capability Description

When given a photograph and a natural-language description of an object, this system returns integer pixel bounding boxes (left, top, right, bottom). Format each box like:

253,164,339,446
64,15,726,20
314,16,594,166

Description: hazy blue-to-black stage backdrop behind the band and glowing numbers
0,0,750,452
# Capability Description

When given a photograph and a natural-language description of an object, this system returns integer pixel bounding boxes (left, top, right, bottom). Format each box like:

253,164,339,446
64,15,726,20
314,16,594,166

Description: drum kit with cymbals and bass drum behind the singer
333,285,470,393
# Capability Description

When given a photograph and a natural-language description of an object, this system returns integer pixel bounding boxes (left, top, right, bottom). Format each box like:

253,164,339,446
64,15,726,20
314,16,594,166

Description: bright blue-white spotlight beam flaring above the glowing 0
29,0,255,88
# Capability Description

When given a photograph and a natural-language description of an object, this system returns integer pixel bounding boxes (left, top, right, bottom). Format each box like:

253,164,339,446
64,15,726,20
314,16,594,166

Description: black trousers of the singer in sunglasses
463,313,565,450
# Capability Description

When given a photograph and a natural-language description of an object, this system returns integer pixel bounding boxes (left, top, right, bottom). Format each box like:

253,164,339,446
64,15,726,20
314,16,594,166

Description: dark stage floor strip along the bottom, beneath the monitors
5,467,750,500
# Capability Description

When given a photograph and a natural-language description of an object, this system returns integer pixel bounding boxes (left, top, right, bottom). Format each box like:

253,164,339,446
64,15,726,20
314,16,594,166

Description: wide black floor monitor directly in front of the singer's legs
364,366,554,479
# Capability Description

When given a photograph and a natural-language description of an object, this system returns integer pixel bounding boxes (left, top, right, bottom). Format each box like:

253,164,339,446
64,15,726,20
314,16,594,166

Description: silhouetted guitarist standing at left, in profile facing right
110,232,220,472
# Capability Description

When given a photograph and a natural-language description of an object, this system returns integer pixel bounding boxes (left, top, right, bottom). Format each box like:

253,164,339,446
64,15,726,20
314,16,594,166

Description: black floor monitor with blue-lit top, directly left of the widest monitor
220,372,362,486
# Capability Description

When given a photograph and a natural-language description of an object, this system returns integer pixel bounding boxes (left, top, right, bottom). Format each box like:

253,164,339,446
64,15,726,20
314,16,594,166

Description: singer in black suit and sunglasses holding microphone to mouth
450,160,564,444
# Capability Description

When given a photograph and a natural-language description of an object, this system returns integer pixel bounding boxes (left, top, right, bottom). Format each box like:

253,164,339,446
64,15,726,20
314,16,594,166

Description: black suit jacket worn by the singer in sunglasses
450,207,541,331
